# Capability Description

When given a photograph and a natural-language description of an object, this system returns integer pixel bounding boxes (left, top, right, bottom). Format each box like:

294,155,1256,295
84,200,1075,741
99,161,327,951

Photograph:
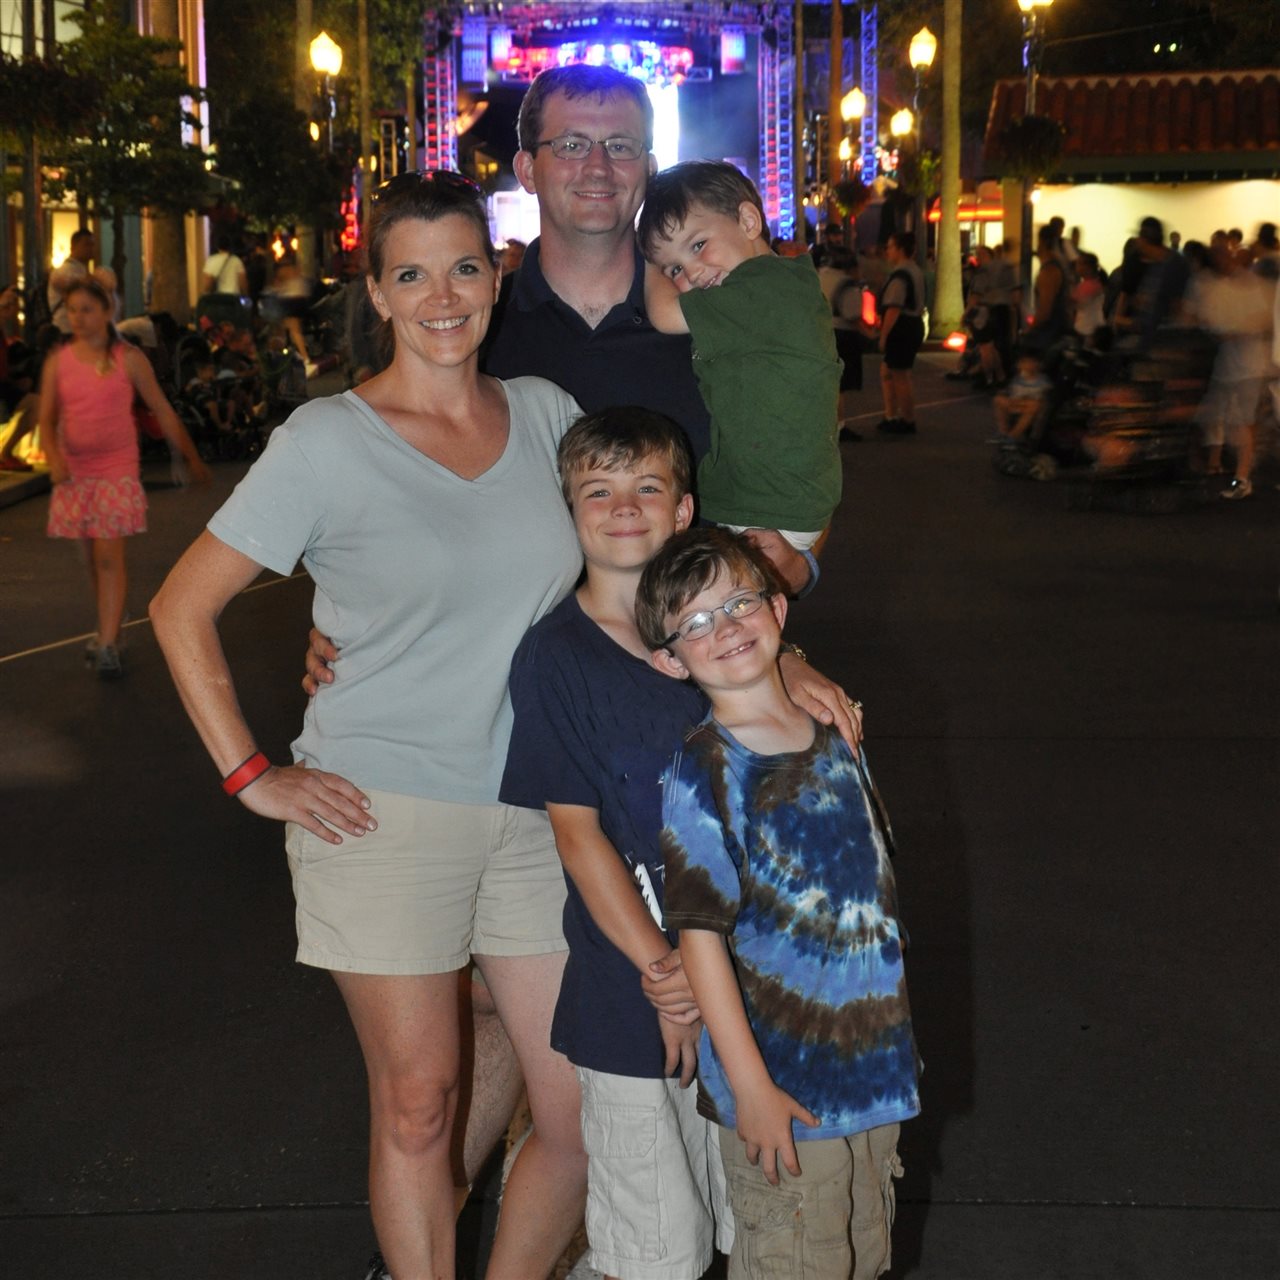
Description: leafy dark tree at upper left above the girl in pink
46,6,207,288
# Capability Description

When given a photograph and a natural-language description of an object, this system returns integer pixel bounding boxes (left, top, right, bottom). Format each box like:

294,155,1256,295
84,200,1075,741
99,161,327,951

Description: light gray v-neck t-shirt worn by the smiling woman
209,378,582,804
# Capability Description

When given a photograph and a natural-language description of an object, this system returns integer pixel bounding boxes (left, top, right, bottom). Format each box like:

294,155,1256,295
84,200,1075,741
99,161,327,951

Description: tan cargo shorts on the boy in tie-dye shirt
719,1124,902,1280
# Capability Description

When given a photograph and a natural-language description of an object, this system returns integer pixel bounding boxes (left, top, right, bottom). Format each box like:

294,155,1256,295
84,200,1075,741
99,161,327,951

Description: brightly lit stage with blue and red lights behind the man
420,0,796,239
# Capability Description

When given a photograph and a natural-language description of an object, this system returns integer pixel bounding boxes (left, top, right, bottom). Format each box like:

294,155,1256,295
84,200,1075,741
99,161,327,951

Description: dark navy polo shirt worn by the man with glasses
484,239,710,460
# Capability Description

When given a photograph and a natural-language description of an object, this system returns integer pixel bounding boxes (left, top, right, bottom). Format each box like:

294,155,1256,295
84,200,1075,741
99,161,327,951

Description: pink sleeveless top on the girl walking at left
56,342,138,480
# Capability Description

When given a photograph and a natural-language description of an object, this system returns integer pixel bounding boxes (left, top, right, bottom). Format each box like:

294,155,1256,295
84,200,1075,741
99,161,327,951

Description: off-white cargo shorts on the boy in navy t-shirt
577,1066,733,1280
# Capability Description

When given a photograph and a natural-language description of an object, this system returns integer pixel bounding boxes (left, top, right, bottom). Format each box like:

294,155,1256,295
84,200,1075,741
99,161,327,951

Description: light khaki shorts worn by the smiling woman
284,787,564,974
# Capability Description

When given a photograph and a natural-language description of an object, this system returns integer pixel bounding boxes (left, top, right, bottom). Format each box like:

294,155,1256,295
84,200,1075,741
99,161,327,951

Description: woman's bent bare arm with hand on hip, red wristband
150,530,376,845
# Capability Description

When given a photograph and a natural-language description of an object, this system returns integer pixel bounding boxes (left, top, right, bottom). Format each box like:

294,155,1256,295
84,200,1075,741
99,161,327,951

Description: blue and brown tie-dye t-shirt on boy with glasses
662,718,920,1140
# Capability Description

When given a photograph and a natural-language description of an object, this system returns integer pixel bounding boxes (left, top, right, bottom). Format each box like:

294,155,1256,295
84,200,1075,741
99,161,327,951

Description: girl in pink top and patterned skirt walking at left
40,279,209,680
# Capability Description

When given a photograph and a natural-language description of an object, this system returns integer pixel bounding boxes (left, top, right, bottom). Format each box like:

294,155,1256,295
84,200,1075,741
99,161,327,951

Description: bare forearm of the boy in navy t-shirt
547,804,698,1024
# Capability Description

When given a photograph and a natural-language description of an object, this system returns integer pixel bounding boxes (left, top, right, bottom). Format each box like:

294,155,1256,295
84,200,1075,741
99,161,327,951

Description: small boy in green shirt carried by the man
637,160,841,567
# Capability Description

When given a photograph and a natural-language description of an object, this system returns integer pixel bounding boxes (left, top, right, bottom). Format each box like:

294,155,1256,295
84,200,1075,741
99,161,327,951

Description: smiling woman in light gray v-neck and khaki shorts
152,173,585,1280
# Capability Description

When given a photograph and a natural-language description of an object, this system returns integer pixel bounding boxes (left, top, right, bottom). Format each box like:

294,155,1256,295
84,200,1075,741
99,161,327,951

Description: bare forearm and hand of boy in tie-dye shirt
680,929,820,1187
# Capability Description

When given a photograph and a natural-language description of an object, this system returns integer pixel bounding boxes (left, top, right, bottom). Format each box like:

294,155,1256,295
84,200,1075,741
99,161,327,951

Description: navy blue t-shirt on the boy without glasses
499,595,707,1078
